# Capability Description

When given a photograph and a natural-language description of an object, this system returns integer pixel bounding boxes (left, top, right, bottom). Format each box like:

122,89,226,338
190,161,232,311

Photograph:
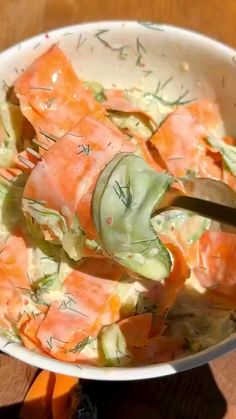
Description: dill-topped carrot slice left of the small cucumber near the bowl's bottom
37,271,120,361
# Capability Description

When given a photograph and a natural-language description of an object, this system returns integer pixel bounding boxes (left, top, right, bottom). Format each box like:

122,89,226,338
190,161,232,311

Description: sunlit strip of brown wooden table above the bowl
0,0,236,49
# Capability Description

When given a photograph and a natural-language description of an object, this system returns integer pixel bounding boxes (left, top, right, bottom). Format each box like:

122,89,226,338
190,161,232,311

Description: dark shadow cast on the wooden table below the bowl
81,365,227,419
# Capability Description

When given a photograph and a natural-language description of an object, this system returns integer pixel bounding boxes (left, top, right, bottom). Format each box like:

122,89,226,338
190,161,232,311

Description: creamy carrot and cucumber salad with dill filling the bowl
0,23,236,379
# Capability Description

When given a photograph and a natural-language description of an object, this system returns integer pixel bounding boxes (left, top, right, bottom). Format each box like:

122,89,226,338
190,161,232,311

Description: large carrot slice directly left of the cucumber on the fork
24,117,134,238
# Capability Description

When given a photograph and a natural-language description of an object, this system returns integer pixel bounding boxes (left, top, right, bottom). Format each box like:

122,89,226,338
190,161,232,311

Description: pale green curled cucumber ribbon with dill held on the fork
92,153,174,281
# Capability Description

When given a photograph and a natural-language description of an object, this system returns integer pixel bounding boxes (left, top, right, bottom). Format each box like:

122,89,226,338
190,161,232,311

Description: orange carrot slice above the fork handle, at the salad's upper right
150,100,221,179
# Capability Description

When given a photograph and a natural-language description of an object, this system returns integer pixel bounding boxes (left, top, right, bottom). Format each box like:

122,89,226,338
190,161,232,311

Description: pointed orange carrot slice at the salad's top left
15,45,105,143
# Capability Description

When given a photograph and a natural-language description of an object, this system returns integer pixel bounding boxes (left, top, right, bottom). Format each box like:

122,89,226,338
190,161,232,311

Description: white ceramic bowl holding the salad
0,21,236,380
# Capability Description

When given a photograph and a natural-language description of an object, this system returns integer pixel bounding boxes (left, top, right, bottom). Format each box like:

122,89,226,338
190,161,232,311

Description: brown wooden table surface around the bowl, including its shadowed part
0,0,236,419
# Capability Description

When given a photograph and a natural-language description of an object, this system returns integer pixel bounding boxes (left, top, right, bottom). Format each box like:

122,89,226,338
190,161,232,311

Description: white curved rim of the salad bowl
0,20,236,381
